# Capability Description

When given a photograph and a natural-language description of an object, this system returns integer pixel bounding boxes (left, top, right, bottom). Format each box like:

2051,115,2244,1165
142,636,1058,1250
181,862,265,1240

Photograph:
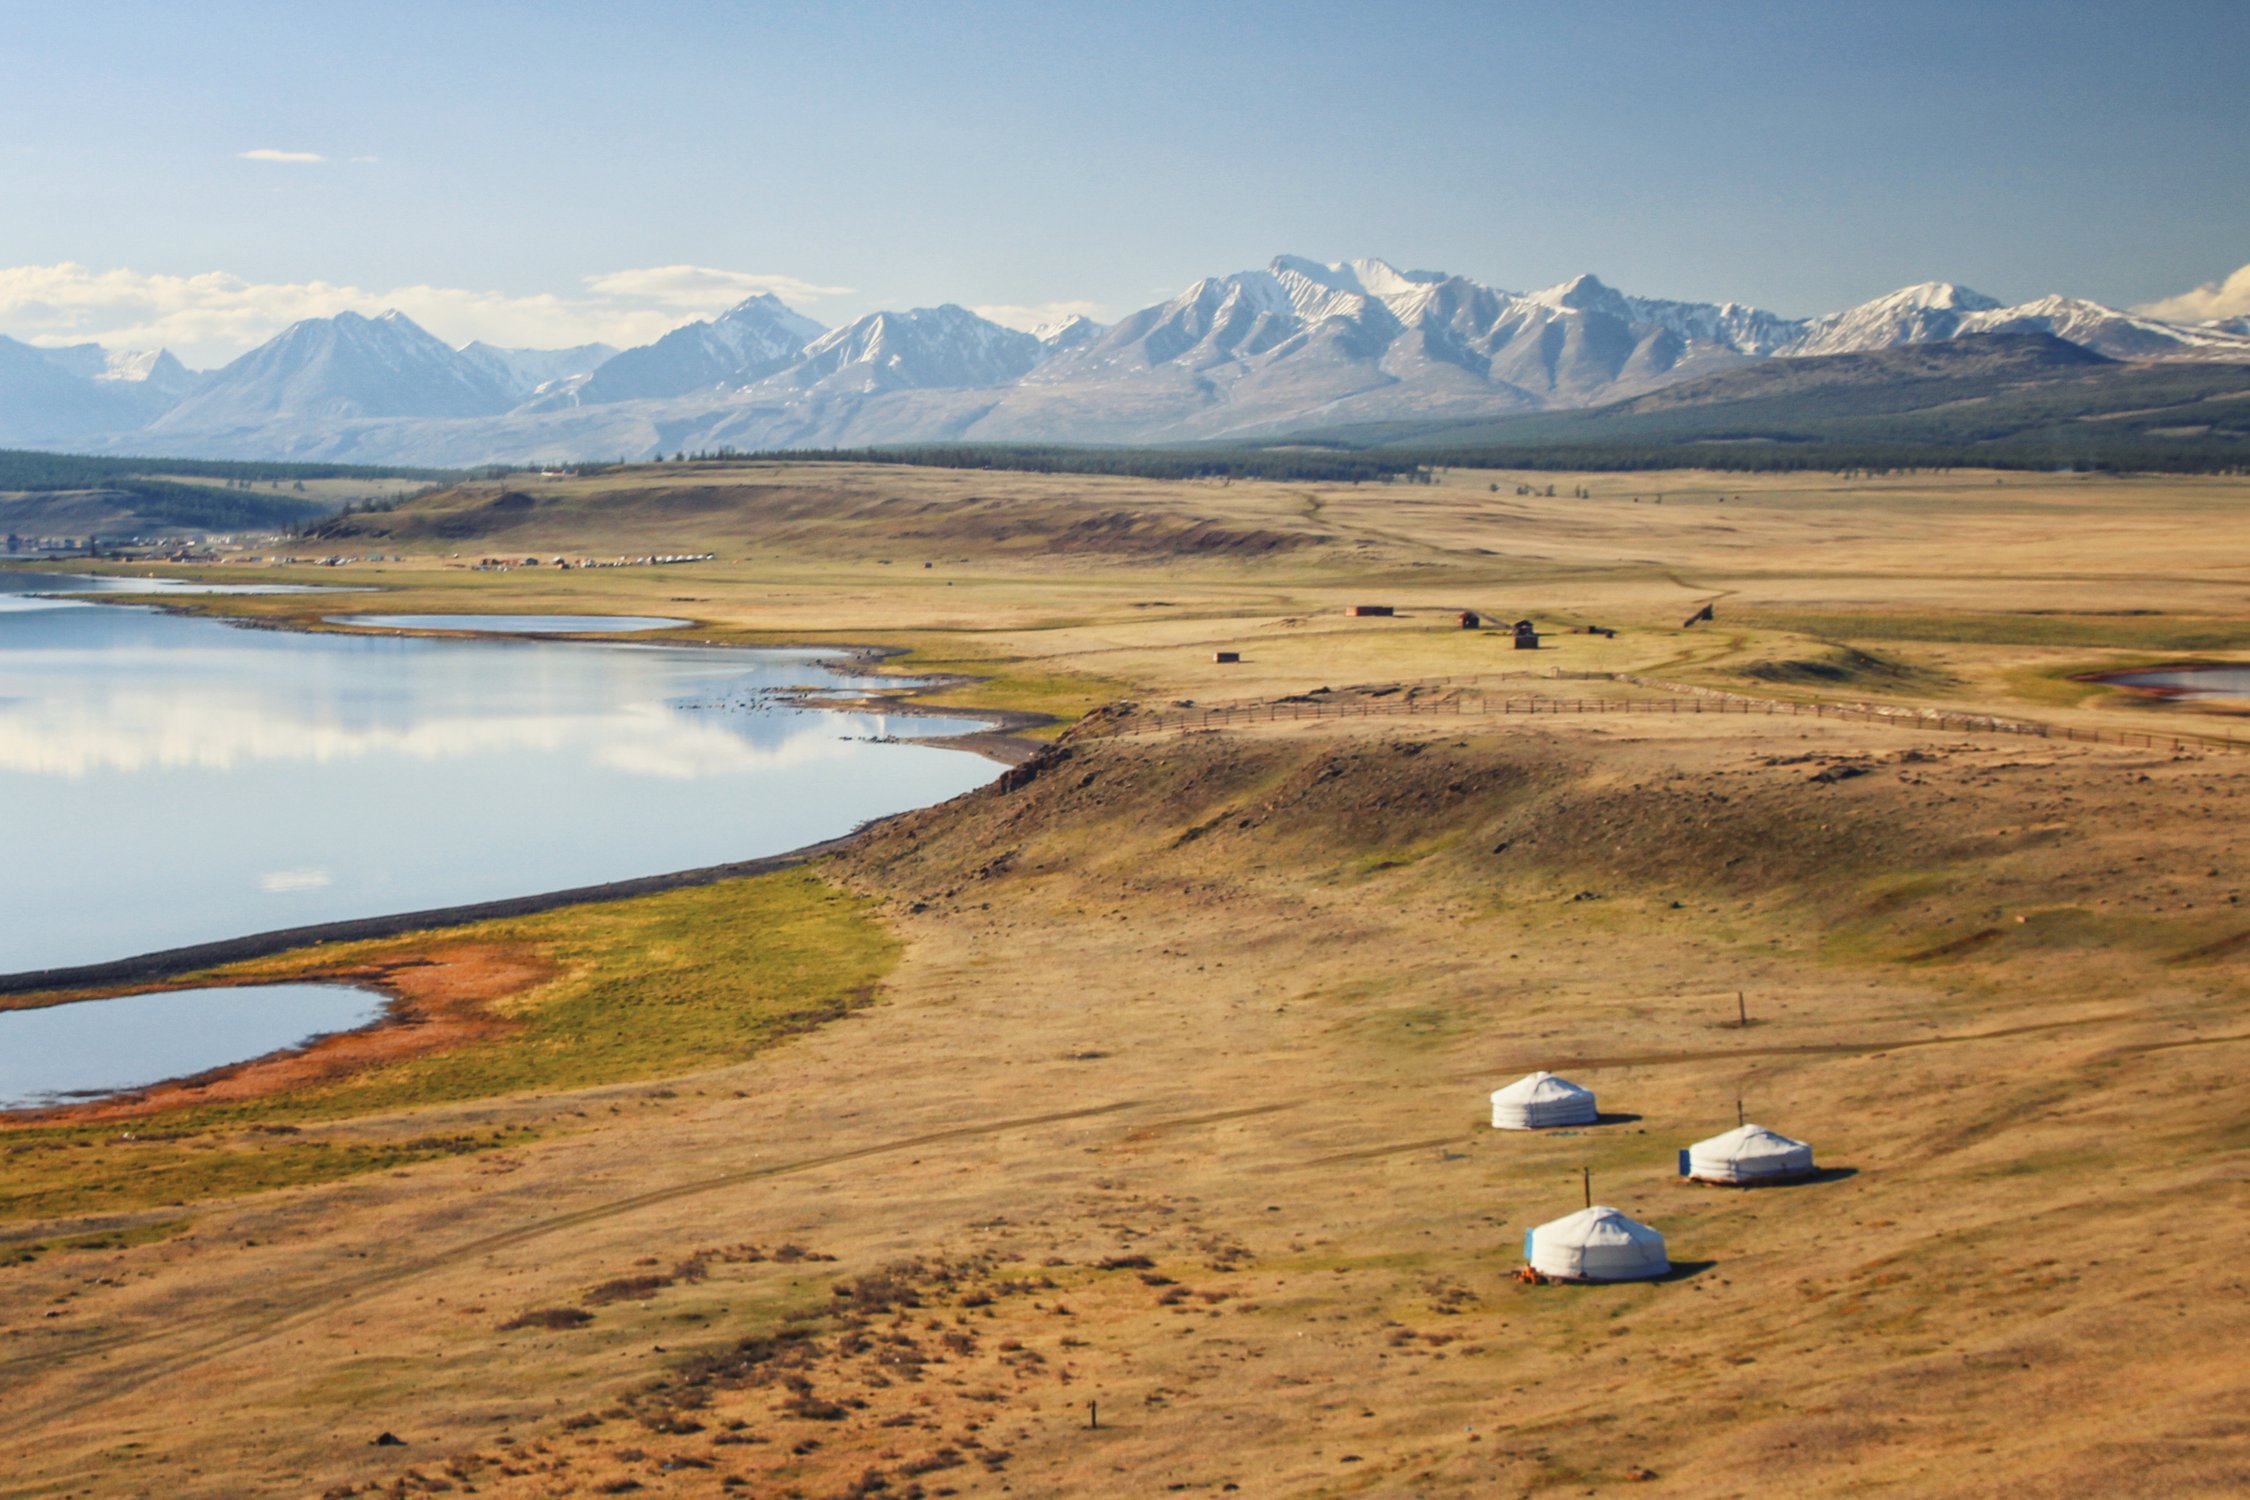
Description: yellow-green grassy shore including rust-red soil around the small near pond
0,870,898,1235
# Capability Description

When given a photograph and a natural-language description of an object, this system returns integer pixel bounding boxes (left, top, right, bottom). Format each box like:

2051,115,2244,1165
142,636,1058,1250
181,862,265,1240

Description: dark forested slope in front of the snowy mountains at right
1298,333,2250,468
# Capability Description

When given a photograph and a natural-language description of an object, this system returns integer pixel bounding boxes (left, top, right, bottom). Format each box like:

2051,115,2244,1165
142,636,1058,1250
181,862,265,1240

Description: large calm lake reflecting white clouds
0,571,995,974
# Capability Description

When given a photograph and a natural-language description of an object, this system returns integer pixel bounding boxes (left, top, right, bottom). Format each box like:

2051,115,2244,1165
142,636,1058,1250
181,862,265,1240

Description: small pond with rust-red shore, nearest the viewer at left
0,985,385,1109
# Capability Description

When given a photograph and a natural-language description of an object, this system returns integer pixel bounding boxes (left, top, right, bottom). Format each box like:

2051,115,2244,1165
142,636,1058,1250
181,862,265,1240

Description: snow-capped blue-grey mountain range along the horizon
0,256,2250,466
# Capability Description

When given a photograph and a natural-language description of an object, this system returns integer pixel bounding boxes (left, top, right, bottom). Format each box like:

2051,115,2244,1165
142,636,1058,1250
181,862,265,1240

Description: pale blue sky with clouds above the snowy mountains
0,0,2250,367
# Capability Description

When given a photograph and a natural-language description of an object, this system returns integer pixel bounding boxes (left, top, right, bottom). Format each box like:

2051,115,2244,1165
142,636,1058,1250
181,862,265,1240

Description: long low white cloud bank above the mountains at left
0,261,848,367
